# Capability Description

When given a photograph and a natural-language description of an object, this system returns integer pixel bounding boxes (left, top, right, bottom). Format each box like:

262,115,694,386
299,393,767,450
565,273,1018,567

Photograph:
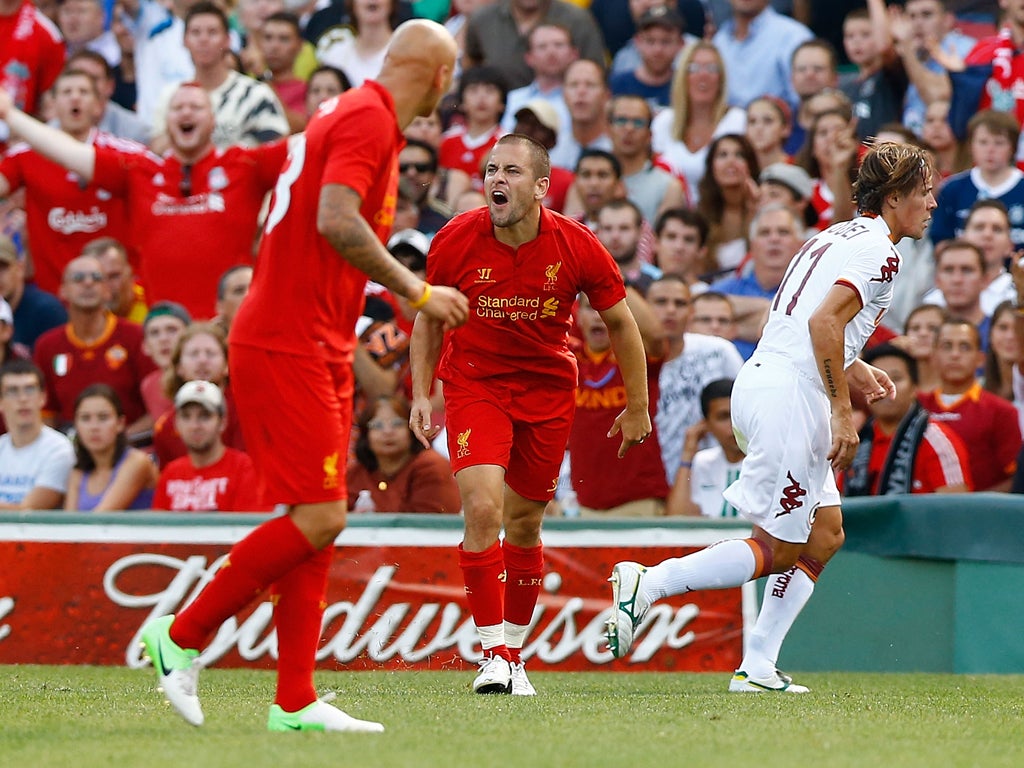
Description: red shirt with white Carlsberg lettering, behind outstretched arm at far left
0,130,145,294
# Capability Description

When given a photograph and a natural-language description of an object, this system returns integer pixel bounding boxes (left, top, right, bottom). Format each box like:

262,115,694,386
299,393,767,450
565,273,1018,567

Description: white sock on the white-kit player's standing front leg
739,566,814,679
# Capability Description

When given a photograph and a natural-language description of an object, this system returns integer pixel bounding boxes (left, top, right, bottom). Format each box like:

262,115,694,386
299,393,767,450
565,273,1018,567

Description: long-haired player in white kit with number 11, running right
607,142,936,693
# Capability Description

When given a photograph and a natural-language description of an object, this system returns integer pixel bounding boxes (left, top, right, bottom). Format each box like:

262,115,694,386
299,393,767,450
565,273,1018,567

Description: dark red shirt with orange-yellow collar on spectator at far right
918,382,1021,490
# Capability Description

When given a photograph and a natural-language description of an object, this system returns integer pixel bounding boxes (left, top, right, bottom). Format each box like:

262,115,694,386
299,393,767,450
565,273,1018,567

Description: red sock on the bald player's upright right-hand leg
272,545,334,712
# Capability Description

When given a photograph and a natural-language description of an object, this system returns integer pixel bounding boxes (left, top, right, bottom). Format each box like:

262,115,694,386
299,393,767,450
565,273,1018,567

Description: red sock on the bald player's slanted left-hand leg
170,515,316,648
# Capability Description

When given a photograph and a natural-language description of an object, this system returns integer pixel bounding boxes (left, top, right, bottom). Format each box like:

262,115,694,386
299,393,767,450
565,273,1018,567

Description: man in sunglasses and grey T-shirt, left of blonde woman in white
608,94,688,221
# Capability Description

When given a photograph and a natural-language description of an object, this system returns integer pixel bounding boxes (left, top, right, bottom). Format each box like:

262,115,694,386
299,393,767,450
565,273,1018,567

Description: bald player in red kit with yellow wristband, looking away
131,19,467,732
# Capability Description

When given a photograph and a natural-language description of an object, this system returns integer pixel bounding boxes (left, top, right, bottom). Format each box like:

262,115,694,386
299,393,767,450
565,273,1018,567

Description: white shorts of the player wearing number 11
724,355,840,544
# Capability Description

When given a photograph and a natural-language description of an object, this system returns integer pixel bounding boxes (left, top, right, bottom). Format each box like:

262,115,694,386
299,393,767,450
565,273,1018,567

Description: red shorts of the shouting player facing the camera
444,380,575,502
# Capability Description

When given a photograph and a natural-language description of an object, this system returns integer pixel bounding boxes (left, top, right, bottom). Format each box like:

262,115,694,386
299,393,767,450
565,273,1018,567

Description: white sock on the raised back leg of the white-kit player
642,539,756,602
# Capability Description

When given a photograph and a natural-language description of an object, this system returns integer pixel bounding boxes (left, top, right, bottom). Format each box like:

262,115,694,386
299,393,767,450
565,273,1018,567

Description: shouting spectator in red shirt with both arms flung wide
0,83,288,318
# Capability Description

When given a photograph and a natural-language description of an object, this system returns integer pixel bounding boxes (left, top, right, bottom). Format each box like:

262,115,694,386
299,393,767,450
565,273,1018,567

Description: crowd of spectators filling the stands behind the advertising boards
0,0,1024,517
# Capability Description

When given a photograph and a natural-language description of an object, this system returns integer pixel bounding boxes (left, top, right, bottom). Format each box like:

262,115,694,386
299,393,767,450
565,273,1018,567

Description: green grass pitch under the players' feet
0,666,1024,768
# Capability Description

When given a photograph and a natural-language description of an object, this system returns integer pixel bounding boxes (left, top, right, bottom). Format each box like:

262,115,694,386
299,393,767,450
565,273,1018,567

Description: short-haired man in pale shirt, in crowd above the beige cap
502,24,580,133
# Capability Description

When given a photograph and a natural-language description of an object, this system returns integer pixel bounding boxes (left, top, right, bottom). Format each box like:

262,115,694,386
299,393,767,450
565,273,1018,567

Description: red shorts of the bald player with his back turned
229,345,354,505
